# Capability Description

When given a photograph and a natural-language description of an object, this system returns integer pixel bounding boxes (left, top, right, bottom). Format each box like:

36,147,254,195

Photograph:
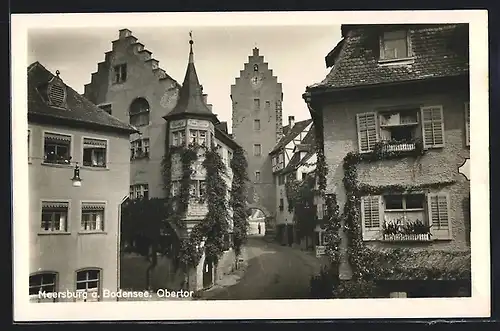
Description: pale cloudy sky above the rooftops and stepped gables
28,25,340,132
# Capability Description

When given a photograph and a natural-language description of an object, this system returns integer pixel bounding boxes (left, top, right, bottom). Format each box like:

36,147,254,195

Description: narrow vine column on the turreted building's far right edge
229,148,248,255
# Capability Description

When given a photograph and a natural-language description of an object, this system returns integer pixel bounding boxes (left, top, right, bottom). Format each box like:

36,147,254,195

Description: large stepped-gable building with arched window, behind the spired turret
84,29,184,198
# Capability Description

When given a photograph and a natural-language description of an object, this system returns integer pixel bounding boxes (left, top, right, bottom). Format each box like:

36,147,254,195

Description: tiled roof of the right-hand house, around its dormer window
308,24,469,90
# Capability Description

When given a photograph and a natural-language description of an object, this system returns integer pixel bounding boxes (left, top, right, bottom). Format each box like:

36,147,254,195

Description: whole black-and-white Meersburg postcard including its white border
12,10,490,321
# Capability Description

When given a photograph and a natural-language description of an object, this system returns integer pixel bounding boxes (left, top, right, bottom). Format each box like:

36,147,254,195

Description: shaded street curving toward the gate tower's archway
200,237,330,300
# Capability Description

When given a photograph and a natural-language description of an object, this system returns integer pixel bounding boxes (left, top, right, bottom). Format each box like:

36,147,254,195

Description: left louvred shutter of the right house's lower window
361,195,382,240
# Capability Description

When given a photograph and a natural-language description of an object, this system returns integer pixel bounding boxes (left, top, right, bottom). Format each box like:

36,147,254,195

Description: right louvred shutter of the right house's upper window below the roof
421,106,444,148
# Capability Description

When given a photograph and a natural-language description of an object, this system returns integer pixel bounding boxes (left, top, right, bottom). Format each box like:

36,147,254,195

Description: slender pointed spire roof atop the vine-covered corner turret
163,32,219,123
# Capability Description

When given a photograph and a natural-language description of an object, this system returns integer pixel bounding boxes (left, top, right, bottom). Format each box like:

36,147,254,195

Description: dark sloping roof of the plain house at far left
28,61,137,133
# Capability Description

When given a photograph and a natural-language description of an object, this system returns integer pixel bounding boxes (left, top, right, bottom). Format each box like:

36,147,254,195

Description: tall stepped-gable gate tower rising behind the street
231,48,283,220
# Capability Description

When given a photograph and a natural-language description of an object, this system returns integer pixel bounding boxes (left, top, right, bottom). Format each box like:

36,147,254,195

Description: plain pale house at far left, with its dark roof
28,62,136,302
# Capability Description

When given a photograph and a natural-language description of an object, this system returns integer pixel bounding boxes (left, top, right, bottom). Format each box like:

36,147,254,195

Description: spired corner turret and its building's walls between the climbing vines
164,40,240,290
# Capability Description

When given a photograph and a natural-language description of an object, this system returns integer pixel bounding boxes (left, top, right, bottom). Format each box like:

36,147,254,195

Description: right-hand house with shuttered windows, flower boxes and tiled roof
304,24,470,297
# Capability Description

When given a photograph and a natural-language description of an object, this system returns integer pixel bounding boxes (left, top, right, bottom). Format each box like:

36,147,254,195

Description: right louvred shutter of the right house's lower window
427,193,451,239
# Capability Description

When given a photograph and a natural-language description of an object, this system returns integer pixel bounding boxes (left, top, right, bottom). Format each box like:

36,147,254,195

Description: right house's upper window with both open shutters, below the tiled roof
356,106,444,153
